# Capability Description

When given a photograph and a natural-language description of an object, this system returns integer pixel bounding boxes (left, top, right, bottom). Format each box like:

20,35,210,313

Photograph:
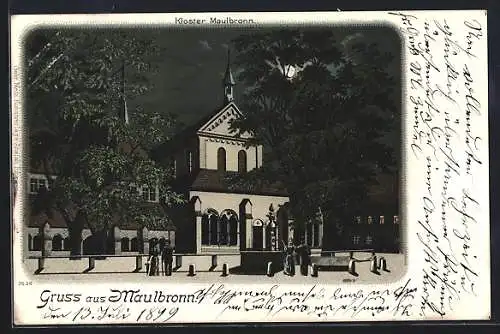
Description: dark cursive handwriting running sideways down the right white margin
391,13,488,317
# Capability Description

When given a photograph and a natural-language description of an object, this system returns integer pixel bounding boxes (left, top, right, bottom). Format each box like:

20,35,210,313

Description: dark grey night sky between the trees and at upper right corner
126,27,401,132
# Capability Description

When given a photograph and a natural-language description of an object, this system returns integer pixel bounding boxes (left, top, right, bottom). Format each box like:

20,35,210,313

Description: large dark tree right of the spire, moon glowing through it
231,29,399,244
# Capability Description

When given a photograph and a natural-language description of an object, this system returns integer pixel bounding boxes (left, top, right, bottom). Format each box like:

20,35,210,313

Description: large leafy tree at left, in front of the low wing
26,30,183,251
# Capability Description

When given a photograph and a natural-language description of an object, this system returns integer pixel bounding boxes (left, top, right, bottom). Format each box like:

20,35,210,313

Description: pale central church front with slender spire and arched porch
164,54,323,253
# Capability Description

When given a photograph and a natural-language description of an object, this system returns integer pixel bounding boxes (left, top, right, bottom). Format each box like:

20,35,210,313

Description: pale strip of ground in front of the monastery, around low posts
22,254,406,284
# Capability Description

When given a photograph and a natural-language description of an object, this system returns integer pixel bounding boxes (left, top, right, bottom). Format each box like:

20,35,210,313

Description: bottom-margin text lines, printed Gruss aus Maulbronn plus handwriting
37,280,417,323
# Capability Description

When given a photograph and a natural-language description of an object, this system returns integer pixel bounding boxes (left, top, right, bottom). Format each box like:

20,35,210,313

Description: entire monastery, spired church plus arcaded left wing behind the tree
24,52,323,255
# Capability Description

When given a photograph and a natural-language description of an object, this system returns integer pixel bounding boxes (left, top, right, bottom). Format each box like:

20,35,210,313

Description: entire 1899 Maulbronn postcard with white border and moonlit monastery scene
10,10,491,326
